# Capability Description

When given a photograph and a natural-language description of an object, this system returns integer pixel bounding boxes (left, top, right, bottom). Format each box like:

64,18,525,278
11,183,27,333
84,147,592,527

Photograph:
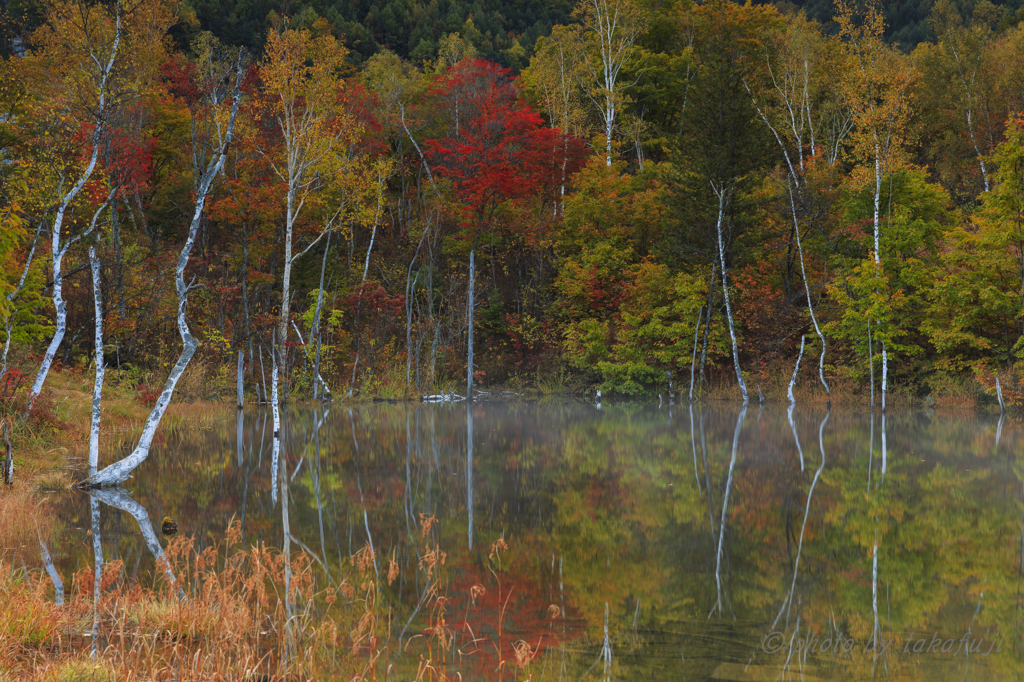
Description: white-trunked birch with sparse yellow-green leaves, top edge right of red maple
573,0,647,166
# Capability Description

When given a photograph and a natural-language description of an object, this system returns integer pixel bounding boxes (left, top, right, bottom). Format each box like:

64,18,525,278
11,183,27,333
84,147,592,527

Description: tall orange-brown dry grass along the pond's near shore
0,516,537,682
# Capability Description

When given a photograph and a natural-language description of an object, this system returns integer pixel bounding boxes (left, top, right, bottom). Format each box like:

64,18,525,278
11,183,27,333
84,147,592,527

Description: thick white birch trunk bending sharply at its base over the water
79,54,244,487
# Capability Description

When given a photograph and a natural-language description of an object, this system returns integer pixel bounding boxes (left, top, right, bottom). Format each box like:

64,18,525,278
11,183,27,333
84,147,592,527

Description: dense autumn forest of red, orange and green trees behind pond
0,0,1024,413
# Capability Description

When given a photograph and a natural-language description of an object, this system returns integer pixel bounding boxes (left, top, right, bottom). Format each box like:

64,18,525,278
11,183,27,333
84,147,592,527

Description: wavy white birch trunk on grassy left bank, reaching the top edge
25,10,121,416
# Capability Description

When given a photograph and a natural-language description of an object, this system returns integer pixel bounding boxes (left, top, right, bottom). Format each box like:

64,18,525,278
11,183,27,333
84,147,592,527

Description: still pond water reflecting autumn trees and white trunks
53,401,1024,680
